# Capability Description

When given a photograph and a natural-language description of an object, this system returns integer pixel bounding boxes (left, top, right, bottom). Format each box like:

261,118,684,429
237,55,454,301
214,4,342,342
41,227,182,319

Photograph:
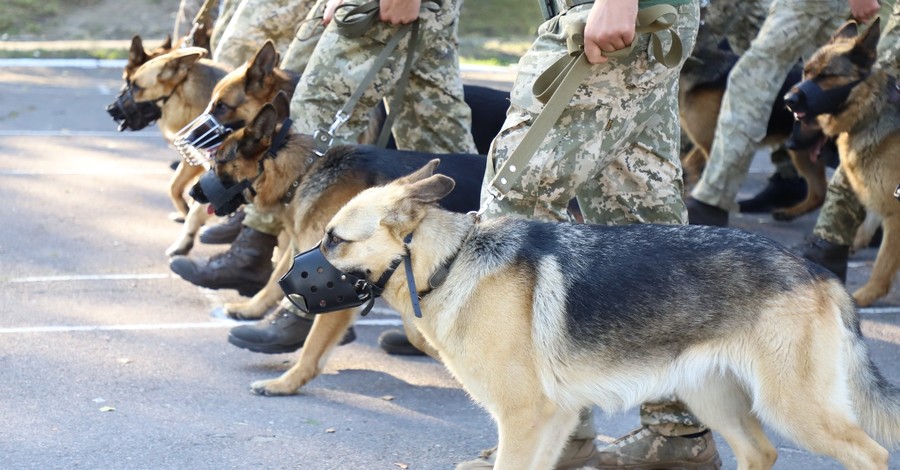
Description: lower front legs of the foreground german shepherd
494,395,578,470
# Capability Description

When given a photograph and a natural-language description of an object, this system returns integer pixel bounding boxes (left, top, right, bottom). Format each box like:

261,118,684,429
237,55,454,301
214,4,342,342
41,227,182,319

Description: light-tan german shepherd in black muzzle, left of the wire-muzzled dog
107,46,228,223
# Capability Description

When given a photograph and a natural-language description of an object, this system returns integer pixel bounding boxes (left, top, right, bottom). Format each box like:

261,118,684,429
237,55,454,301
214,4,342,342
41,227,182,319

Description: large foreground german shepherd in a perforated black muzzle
298,160,900,470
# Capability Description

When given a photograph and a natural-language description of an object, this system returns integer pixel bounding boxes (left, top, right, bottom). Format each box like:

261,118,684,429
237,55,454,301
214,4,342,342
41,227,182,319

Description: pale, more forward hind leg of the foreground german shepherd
677,372,778,470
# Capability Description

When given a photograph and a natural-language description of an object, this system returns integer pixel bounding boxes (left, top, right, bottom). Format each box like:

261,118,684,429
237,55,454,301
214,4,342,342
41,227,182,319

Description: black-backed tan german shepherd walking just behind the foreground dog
208,103,485,394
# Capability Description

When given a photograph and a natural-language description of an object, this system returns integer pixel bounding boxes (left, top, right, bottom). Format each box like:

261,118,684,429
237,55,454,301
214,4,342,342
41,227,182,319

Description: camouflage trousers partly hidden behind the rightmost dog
813,2,900,246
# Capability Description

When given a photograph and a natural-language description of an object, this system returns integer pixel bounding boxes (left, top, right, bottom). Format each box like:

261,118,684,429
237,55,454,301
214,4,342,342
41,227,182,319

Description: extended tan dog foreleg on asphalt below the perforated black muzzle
250,309,356,396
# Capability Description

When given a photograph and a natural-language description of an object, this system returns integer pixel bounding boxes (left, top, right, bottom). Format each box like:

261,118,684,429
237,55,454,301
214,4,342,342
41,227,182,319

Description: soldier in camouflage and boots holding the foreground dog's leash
457,0,719,469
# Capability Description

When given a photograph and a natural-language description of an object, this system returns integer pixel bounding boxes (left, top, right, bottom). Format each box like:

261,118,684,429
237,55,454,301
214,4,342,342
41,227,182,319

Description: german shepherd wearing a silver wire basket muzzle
166,41,299,256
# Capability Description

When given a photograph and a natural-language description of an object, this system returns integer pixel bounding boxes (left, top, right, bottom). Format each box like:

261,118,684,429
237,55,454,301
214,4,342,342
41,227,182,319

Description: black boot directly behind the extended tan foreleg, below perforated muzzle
228,305,356,354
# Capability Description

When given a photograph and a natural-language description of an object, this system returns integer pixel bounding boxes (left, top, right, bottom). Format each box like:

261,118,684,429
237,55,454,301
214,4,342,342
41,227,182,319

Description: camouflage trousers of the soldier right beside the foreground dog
482,2,705,458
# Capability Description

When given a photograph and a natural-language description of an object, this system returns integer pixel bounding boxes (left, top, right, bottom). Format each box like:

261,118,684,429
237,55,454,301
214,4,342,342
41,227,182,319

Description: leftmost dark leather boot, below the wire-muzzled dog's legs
169,226,278,297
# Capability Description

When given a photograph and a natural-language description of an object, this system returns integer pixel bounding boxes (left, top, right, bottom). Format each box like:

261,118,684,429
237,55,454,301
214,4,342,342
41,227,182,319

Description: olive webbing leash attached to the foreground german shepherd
486,4,683,216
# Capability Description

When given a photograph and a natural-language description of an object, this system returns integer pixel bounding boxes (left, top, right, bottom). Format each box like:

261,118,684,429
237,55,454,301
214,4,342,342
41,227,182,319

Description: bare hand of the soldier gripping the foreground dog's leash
584,0,638,64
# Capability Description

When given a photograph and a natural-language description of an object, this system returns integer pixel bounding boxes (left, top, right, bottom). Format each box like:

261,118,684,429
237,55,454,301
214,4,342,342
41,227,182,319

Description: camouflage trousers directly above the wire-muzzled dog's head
212,0,313,67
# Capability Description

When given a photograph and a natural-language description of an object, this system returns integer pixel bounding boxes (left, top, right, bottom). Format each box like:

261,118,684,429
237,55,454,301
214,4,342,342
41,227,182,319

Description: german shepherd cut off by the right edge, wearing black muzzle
785,19,900,306
